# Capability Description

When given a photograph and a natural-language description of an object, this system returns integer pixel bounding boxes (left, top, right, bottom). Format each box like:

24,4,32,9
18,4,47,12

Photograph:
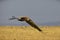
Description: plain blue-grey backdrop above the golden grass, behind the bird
0,0,60,25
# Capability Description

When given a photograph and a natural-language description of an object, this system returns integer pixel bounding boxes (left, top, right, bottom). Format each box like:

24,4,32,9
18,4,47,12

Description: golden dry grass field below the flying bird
0,26,60,40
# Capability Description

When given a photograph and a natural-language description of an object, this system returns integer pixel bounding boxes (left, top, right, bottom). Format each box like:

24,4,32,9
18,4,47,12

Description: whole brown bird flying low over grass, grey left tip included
9,16,42,31
